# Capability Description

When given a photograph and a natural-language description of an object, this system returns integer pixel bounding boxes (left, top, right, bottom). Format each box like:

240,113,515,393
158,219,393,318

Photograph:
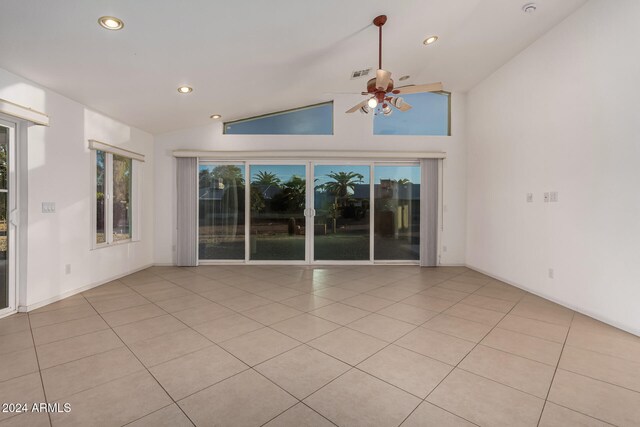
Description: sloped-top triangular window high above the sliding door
224,102,333,135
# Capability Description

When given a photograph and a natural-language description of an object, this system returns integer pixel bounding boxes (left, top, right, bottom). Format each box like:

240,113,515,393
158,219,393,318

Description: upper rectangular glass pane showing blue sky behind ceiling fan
373,92,450,136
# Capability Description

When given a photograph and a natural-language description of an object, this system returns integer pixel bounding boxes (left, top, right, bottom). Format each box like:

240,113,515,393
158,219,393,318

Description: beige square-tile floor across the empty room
0,266,640,427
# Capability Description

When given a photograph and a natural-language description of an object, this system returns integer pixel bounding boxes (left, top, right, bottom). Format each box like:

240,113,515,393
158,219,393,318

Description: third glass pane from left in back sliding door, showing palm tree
313,165,370,260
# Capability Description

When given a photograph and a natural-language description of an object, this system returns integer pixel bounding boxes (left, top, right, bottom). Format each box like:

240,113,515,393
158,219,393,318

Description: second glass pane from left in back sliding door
250,165,306,261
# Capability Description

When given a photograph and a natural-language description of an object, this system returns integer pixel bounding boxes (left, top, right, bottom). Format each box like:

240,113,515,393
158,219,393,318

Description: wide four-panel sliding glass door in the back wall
199,161,421,263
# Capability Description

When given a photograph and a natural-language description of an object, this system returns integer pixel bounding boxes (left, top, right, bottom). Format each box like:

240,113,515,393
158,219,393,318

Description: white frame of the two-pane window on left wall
90,148,142,250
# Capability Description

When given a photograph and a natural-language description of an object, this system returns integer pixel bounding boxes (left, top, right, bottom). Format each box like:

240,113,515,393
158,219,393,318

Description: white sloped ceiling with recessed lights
0,0,586,134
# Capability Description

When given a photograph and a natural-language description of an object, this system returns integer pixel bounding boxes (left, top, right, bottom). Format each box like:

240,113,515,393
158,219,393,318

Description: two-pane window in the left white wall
93,149,137,247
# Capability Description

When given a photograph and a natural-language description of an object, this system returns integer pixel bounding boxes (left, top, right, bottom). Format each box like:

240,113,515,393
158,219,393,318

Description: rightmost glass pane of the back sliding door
373,165,420,260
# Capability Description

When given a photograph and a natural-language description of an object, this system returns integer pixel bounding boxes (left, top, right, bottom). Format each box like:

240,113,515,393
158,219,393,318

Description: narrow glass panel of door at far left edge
0,126,9,309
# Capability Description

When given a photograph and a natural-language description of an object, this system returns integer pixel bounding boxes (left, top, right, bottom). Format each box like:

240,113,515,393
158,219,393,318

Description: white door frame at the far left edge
0,118,20,317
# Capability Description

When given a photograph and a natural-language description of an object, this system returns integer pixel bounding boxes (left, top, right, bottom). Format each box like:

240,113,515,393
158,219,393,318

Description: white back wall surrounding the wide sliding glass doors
155,93,466,264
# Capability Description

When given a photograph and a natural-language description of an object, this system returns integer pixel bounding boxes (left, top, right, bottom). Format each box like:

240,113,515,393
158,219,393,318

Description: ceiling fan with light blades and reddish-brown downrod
346,15,442,116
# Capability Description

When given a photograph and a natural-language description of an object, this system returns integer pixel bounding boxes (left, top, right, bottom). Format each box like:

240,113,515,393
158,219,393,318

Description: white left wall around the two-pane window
0,69,154,307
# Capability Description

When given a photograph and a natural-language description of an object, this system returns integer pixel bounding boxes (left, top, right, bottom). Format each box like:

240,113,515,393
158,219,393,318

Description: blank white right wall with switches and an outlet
466,0,640,334
